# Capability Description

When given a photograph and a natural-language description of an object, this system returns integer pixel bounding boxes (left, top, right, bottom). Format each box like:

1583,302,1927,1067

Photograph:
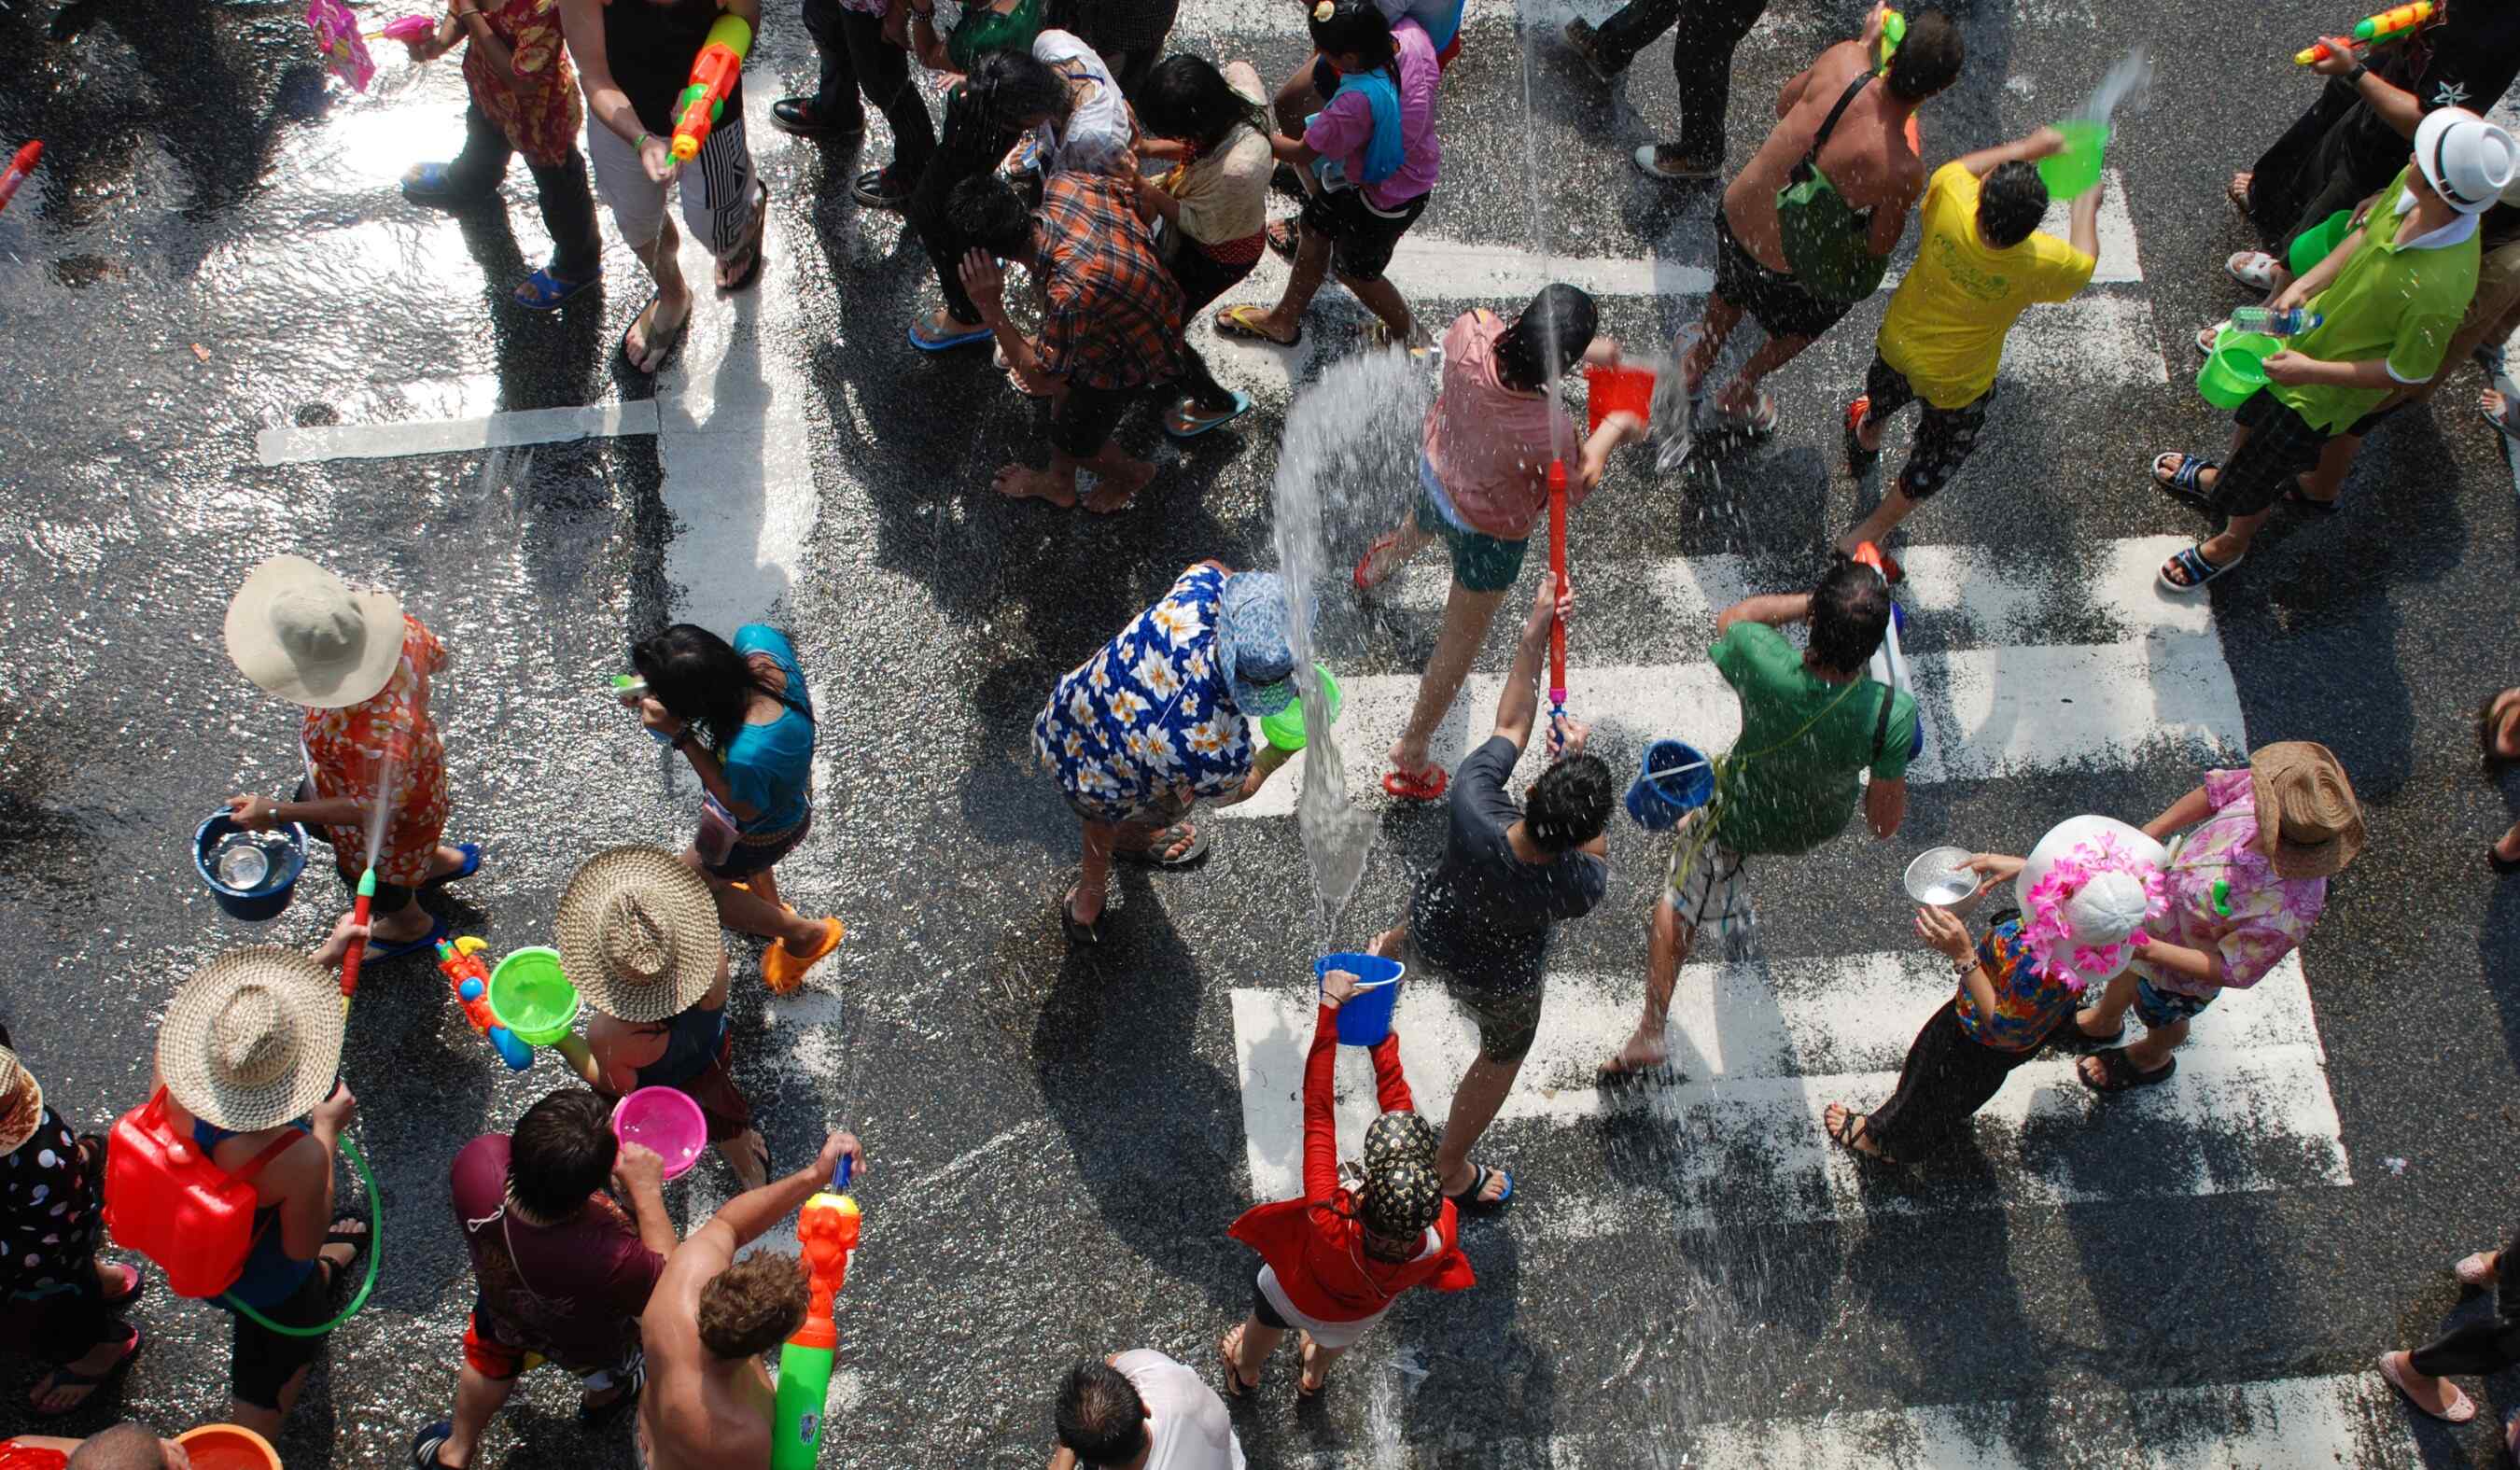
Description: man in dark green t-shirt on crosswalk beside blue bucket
1601,557,1915,1077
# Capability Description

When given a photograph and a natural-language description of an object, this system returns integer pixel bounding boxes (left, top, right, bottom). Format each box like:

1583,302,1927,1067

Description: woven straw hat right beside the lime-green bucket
559,847,726,1021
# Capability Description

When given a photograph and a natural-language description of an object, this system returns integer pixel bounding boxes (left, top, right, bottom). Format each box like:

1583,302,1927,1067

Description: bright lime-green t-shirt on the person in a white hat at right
2265,172,2477,434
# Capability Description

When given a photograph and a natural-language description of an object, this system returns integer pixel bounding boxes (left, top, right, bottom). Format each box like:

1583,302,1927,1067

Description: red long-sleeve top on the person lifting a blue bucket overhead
1227,1006,1477,1322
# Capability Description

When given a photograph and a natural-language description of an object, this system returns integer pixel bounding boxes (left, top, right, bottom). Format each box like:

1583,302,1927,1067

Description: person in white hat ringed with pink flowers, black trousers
1819,817,2170,1162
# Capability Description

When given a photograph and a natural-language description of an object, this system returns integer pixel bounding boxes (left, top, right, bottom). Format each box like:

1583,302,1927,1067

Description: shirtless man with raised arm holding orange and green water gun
637,1132,867,1470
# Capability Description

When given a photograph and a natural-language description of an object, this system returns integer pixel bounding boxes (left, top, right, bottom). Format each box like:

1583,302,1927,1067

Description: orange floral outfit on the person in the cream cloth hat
300,612,446,888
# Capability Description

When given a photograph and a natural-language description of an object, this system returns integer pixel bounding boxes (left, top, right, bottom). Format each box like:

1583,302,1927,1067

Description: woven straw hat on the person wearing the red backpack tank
159,945,343,1132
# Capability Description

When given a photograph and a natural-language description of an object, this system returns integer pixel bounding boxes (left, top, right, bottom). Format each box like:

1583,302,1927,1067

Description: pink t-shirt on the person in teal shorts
1426,310,1585,542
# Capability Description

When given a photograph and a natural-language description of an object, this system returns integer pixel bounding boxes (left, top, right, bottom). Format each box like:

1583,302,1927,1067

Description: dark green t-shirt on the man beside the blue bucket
1711,621,1915,858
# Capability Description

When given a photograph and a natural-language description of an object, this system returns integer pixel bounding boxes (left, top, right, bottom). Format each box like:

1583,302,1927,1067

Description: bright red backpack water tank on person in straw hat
105,1086,298,1296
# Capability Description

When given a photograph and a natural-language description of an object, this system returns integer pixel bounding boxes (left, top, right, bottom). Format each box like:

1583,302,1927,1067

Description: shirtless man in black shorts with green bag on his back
1681,5,1961,434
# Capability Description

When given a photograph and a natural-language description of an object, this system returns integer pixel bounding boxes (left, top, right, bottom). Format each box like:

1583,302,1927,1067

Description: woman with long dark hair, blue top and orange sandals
630,623,845,993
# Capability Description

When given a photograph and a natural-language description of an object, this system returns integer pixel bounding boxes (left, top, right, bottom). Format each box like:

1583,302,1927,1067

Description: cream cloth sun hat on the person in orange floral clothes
227,557,403,708
